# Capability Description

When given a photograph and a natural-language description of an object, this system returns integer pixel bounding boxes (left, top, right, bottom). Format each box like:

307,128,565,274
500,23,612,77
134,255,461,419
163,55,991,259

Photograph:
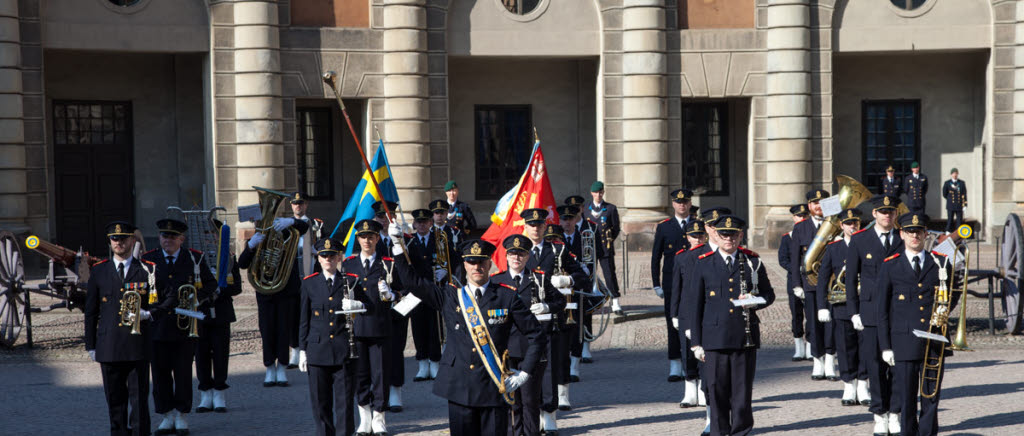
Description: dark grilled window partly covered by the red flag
473,105,534,200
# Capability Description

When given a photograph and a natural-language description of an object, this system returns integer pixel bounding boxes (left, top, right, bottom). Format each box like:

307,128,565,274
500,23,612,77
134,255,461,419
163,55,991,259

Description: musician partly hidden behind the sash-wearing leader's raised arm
407,209,442,382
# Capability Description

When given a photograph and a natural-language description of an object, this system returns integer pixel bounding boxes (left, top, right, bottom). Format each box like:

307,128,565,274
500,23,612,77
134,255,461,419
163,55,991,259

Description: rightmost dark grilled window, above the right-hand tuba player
861,100,921,192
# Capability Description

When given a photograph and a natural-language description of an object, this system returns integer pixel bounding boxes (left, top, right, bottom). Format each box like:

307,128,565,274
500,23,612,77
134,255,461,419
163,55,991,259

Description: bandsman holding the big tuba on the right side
786,189,836,380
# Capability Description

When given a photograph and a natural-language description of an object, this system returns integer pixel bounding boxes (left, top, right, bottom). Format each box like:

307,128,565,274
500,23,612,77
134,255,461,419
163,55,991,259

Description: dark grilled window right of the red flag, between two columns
682,102,729,195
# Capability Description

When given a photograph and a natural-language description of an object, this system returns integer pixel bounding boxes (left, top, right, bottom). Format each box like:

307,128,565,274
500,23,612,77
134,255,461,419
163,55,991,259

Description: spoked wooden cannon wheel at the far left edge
0,231,25,347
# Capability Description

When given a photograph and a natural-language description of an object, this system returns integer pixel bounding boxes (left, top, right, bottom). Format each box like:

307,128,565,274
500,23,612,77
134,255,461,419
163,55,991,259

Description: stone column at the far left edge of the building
0,0,29,233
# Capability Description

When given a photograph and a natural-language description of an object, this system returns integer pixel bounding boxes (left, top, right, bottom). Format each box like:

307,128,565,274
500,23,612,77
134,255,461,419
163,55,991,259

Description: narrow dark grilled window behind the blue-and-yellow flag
295,107,334,200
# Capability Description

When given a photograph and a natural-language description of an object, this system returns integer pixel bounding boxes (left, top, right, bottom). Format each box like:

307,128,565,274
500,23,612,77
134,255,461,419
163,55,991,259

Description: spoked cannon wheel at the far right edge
999,214,1024,335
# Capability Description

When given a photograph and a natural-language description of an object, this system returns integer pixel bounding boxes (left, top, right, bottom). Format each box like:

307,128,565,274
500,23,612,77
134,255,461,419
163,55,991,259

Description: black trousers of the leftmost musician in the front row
99,360,150,436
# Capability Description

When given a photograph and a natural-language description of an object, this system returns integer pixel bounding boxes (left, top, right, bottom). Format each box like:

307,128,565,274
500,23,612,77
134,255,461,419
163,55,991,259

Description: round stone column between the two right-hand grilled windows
752,0,811,246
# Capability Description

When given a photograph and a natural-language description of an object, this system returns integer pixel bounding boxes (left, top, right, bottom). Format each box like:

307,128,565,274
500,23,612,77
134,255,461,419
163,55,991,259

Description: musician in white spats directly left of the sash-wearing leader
342,219,403,434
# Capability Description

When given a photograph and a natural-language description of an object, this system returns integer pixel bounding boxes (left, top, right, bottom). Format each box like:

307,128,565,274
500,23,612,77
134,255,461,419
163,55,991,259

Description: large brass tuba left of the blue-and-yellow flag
248,186,302,294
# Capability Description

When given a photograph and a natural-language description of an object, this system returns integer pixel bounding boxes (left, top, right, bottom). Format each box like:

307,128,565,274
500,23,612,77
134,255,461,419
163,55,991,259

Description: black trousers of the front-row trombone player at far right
893,360,945,435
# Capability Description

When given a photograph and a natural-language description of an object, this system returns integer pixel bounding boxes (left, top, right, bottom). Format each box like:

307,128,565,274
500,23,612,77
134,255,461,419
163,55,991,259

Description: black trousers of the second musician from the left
150,341,196,413
